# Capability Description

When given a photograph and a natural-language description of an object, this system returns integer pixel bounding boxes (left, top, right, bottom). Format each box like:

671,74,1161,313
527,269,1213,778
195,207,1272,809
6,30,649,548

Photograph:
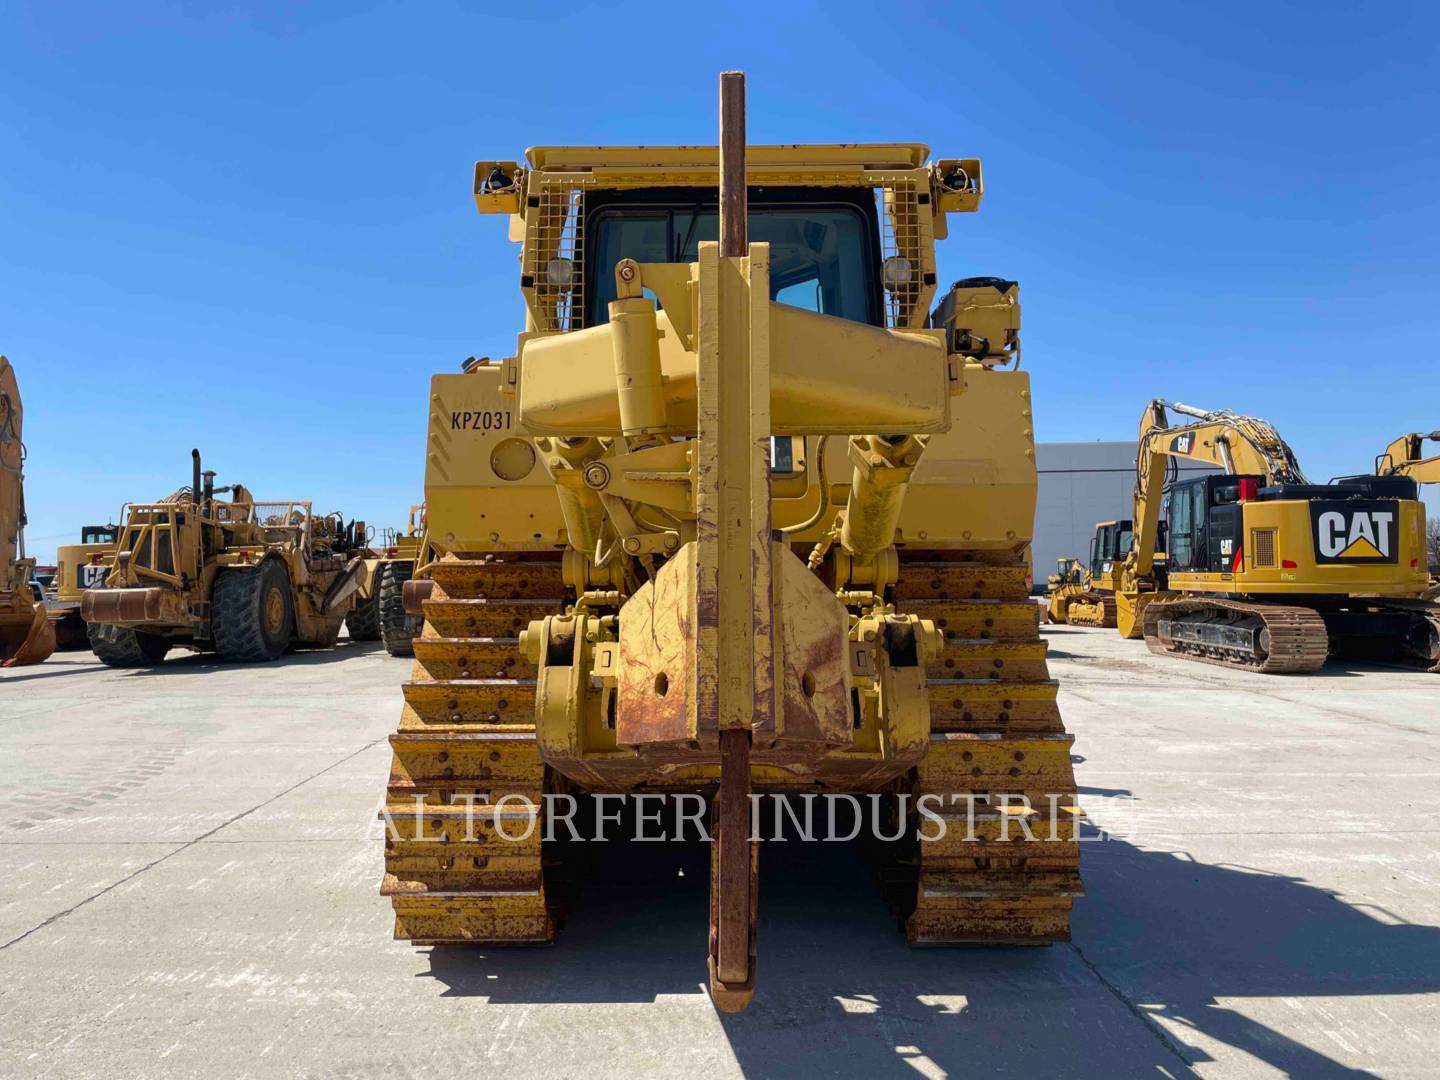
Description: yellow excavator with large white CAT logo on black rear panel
1116,399,1440,672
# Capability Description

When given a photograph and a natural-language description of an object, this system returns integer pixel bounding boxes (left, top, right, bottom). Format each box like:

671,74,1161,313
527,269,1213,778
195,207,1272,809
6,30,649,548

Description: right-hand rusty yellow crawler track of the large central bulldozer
893,552,1083,945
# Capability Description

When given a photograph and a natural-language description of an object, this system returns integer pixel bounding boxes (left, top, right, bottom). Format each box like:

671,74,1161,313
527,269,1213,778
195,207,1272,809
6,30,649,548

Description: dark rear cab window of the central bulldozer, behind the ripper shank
585,196,881,327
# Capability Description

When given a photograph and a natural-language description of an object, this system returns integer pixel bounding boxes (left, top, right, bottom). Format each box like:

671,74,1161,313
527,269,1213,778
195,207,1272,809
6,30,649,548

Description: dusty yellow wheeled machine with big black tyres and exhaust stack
81,451,366,667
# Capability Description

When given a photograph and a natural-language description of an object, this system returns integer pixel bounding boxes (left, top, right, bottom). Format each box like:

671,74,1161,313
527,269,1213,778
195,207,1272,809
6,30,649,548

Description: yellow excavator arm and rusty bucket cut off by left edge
0,356,55,668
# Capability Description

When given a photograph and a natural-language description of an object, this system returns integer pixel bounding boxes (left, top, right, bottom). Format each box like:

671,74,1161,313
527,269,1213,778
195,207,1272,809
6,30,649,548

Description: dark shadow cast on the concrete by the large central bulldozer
420,823,1440,1077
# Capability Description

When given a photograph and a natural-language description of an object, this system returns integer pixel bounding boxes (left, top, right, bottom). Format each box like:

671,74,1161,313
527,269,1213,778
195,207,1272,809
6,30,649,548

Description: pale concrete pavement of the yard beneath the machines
0,626,1440,1077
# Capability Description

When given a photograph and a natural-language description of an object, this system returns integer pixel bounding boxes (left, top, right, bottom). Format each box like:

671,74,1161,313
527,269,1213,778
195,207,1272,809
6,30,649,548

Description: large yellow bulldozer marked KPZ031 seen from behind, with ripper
383,73,1080,1009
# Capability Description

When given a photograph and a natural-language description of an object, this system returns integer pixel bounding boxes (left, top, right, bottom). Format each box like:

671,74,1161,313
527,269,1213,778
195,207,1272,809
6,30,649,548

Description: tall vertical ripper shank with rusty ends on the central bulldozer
696,72,776,1011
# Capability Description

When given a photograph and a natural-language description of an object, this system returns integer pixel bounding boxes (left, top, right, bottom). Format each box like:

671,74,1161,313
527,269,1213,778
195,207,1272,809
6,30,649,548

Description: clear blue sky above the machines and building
0,0,1440,554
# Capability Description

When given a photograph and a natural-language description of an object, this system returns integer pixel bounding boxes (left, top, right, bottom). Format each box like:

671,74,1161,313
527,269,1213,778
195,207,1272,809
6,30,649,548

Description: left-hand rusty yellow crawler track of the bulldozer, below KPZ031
380,553,564,945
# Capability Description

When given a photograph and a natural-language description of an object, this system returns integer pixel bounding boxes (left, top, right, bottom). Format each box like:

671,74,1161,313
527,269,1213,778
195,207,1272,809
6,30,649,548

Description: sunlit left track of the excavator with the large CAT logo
1145,599,1331,674
